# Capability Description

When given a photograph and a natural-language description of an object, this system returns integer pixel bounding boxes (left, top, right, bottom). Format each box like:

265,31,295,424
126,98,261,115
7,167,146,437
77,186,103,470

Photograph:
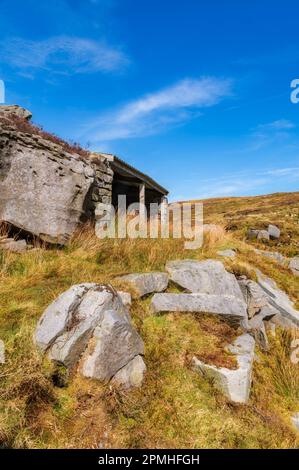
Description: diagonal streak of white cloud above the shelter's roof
86,78,231,143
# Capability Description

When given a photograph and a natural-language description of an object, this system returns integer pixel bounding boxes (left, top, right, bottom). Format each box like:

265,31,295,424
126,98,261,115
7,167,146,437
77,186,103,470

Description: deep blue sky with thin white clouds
0,0,299,200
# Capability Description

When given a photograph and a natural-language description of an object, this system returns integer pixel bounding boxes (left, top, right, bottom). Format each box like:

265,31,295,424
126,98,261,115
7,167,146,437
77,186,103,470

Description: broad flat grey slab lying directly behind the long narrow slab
166,259,243,300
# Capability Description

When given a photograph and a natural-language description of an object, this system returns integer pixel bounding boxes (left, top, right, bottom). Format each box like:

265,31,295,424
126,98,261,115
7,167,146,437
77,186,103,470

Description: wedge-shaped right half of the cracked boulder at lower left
82,310,144,381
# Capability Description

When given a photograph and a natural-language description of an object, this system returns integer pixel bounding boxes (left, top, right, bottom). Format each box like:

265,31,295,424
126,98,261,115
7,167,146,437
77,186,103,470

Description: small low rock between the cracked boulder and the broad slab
117,272,168,297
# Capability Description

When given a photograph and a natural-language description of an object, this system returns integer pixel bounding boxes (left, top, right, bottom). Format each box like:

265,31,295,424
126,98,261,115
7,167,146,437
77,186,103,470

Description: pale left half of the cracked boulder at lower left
34,284,129,367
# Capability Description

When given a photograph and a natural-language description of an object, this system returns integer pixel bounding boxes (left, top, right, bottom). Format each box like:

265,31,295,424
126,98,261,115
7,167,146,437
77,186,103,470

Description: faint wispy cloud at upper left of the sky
0,36,128,75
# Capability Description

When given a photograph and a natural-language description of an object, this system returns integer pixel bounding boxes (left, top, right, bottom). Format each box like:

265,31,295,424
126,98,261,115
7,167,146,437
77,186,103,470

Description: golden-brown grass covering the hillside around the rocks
0,193,299,448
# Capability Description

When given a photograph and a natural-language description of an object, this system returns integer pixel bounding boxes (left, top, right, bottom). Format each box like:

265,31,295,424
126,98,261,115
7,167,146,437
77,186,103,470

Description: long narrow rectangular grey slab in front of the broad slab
151,293,247,325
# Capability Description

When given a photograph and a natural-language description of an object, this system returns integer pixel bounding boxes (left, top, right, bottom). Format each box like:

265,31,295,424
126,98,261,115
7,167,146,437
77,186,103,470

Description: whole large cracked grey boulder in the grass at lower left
34,283,145,387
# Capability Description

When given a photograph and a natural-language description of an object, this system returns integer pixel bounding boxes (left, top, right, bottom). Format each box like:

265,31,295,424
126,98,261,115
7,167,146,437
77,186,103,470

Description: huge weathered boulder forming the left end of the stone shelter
0,121,95,244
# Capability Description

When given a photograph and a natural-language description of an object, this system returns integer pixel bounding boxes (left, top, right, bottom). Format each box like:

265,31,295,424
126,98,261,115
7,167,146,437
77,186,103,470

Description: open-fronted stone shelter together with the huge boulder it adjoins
0,106,168,244
